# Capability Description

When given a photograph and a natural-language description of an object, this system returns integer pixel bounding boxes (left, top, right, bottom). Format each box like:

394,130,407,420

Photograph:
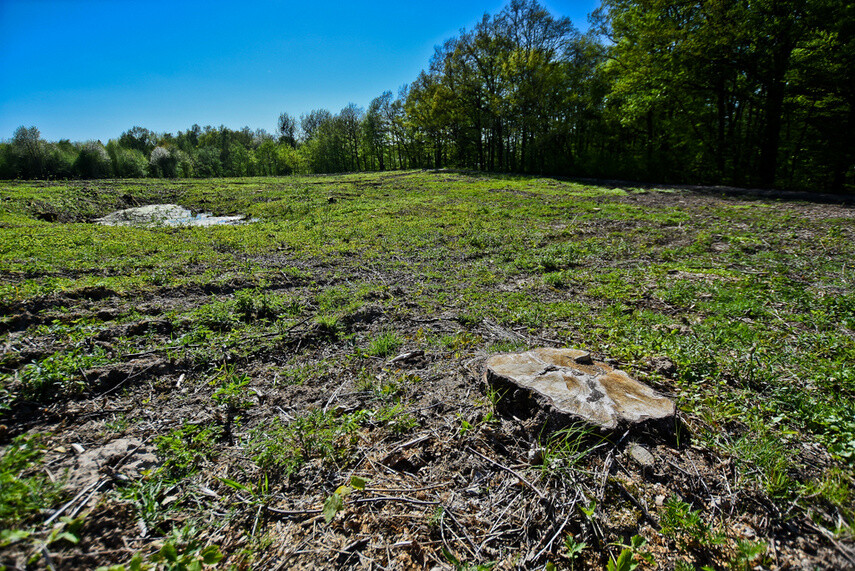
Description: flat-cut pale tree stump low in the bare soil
484,348,675,430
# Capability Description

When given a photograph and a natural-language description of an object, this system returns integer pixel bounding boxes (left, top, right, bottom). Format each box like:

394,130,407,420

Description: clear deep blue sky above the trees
0,0,599,143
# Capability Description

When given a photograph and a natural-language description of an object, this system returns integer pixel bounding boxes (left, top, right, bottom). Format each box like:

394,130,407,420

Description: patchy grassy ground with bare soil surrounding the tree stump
0,172,855,570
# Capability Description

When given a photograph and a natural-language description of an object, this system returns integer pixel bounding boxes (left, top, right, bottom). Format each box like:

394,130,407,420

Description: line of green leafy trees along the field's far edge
0,0,855,191
